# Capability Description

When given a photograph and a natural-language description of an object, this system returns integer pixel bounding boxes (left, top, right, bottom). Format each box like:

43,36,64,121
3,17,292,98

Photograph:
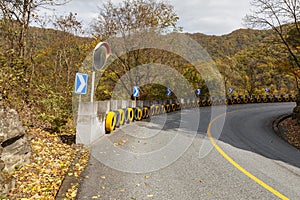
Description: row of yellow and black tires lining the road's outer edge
105,95,296,133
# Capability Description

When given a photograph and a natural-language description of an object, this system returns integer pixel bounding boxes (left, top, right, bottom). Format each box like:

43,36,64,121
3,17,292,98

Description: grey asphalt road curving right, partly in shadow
77,103,300,200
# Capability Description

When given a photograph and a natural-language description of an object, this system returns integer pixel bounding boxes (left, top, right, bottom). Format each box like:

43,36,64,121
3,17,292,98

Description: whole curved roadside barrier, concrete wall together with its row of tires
76,95,296,146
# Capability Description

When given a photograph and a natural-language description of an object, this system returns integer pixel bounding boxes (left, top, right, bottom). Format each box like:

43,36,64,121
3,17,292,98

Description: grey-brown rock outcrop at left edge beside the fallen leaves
0,108,31,196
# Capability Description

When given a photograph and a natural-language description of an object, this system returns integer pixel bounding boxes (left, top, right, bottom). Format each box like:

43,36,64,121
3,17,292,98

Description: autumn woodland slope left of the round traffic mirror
0,21,93,132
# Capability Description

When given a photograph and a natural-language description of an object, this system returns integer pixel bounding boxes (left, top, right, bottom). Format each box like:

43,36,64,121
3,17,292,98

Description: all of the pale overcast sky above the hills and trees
39,0,250,35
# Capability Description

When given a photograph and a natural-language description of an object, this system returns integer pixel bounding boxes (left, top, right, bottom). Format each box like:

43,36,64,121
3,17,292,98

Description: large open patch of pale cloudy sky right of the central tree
173,0,249,35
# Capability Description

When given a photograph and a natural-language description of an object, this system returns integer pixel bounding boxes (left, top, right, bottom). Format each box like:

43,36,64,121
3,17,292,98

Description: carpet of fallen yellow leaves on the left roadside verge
9,129,87,199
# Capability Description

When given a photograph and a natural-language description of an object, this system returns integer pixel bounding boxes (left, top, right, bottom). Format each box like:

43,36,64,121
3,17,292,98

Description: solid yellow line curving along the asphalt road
207,111,289,200
